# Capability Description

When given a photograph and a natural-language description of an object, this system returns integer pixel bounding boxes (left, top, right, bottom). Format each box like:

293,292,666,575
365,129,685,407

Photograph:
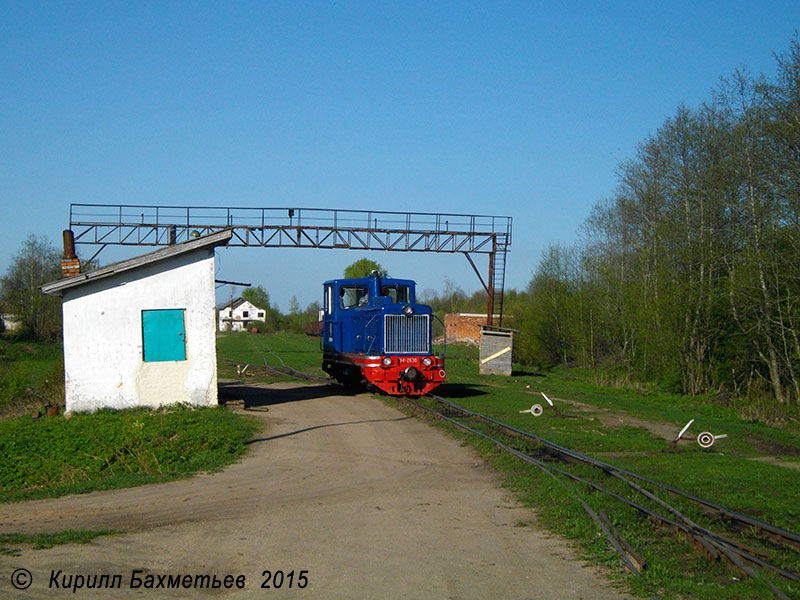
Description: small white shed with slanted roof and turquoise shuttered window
41,230,231,411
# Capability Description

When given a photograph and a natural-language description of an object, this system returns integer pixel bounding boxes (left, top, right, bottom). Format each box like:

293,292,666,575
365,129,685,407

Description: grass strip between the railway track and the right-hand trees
440,346,800,460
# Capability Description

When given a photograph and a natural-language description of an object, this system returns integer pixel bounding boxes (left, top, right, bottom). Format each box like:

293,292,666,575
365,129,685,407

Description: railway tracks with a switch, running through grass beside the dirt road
230,340,800,600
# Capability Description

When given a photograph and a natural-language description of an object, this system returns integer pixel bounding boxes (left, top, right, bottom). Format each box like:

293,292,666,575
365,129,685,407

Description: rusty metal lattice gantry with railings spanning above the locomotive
69,204,511,325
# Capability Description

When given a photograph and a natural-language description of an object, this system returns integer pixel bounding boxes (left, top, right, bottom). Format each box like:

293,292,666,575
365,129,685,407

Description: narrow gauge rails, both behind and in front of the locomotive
231,340,800,600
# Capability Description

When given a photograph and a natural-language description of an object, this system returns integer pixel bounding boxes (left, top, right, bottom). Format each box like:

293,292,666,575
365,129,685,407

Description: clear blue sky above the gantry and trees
0,0,800,311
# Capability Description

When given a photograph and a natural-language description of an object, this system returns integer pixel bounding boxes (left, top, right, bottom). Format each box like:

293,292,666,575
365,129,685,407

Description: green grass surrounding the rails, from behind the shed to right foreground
219,334,800,599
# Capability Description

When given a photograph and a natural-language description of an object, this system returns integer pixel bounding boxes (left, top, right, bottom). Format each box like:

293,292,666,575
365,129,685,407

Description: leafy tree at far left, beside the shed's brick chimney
0,234,61,340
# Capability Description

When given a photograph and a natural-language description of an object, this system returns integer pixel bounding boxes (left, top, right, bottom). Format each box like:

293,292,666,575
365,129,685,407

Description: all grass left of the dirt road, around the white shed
0,338,258,555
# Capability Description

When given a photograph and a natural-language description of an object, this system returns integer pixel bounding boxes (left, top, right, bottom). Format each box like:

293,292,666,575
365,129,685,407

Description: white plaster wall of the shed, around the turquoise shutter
62,248,217,411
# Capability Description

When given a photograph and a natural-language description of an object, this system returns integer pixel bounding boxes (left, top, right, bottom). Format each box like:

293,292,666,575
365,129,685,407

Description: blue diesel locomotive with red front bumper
320,271,445,395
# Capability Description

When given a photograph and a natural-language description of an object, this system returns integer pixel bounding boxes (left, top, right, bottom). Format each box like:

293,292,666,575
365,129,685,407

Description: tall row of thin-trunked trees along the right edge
523,37,800,418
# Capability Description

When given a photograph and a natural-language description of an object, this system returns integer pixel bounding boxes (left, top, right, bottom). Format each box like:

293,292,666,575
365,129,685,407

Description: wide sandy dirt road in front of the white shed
0,384,622,600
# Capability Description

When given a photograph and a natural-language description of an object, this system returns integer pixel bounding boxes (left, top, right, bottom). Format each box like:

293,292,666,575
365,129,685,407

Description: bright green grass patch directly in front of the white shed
0,405,257,502
